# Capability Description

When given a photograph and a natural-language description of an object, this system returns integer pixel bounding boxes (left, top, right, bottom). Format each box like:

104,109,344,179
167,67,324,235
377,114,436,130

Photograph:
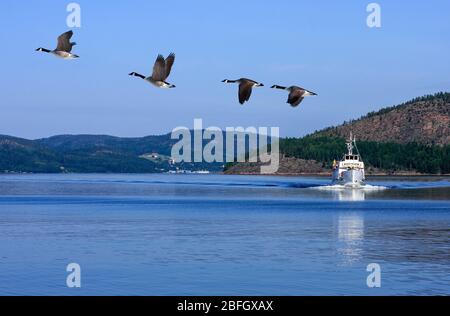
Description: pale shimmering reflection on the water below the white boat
337,213,364,265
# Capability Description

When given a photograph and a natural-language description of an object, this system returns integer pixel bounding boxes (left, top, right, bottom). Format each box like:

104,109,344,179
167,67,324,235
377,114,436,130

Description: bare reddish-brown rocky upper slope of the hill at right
312,92,450,146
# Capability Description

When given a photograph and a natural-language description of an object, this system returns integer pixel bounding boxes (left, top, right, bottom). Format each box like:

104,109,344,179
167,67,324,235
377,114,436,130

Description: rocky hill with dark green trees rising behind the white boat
226,93,450,174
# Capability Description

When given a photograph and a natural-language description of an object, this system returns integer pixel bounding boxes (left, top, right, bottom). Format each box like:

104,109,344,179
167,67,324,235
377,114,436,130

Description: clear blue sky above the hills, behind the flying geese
0,0,450,138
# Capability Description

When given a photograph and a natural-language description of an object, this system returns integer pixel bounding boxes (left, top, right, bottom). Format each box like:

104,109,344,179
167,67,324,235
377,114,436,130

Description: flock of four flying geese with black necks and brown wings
36,31,317,107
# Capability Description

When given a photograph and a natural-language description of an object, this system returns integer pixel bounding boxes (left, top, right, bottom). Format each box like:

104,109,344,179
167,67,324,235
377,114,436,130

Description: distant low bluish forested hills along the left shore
0,134,223,173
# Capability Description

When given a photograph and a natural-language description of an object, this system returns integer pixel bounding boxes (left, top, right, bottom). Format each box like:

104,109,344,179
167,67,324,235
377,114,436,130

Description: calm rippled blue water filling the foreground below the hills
0,175,450,295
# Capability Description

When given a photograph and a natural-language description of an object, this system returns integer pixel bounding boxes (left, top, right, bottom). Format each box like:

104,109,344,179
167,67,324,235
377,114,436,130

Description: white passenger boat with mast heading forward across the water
332,133,366,188
